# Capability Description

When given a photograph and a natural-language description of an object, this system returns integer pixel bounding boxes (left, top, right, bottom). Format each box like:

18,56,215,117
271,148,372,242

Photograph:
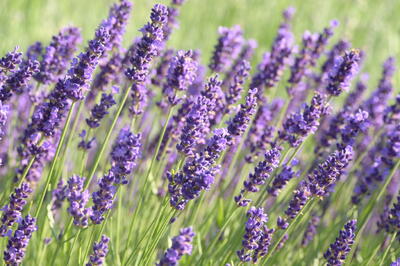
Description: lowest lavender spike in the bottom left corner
4,215,37,265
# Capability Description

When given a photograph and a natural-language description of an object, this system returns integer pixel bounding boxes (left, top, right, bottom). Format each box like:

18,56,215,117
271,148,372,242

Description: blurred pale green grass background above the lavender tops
0,0,400,90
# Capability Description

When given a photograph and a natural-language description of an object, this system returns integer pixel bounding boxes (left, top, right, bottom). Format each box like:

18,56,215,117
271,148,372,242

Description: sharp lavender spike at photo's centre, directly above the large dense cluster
176,96,213,157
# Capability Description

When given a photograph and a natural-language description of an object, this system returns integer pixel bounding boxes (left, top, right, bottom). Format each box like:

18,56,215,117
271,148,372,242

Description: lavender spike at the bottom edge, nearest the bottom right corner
324,220,357,266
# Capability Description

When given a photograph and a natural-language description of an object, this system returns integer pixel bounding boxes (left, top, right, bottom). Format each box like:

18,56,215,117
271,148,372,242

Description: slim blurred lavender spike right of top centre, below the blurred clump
225,60,250,113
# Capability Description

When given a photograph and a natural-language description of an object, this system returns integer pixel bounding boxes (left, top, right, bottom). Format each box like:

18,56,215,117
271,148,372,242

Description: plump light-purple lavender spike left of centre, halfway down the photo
110,129,141,185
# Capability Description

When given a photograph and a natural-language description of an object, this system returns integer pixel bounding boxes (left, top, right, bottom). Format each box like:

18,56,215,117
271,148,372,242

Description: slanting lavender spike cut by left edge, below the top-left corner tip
0,59,39,103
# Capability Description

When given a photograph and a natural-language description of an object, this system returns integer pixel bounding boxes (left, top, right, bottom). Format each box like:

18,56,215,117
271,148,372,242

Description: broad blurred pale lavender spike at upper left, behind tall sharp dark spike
33,27,81,84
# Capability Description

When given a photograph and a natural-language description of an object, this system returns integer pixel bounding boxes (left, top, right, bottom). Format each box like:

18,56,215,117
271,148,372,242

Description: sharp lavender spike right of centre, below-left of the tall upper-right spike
279,93,326,147
